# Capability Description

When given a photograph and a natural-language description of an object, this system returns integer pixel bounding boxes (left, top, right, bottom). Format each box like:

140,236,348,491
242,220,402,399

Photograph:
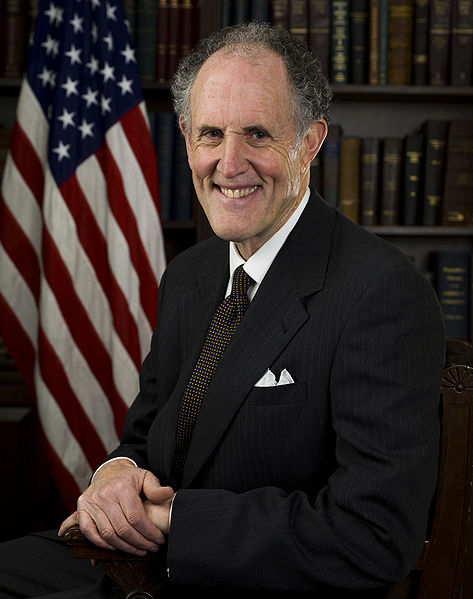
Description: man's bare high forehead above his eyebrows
191,49,289,129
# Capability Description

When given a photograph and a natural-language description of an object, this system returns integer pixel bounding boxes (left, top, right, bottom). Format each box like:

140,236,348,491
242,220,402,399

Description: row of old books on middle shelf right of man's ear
311,119,473,226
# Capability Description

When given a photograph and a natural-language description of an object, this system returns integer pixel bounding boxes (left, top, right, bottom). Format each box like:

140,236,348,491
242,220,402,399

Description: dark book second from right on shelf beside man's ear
422,119,448,227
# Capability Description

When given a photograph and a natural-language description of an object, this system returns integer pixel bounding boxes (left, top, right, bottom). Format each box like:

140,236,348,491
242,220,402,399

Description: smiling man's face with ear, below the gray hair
180,50,326,259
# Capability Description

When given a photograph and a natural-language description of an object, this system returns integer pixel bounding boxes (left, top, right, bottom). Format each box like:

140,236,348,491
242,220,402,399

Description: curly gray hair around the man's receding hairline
171,21,332,142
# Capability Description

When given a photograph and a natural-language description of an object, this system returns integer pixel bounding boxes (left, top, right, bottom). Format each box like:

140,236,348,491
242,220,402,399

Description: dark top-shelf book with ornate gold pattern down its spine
330,0,350,84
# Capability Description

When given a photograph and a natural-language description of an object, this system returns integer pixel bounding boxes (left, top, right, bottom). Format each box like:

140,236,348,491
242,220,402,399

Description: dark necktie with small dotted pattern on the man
172,265,253,482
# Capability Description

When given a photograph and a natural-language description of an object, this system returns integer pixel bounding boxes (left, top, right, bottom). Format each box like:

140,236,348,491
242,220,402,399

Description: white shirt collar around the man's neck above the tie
227,188,310,299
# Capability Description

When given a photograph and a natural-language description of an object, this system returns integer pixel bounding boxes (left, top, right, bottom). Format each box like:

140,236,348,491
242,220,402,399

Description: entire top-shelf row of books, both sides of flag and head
0,0,473,85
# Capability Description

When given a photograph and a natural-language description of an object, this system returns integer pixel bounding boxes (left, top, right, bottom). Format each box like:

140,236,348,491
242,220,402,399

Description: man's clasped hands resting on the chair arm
58,459,174,555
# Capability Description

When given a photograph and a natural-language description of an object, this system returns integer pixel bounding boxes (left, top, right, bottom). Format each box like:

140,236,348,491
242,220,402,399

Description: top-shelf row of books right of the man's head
222,0,473,85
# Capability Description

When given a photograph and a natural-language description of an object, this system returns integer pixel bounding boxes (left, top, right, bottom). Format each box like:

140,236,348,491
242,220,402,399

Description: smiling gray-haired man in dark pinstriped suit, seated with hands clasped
0,24,444,598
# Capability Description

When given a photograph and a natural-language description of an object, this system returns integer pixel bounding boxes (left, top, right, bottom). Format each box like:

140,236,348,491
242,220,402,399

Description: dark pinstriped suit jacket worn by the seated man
112,196,444,597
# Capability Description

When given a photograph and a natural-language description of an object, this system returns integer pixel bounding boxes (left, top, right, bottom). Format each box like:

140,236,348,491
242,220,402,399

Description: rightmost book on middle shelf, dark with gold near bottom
442,119,473,226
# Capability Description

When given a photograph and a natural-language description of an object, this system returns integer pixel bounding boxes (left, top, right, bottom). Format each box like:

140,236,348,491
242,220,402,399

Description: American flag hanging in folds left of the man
0,0,165,509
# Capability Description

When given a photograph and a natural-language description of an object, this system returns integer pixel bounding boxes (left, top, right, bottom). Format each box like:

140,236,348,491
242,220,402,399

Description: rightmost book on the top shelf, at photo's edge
450,0,473,85
